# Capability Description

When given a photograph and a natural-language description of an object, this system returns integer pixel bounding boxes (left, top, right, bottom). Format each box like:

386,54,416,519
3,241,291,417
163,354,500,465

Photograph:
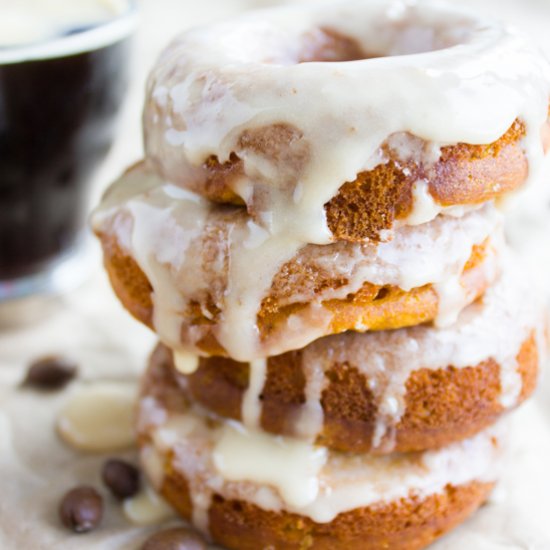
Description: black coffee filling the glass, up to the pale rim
0,1,133,282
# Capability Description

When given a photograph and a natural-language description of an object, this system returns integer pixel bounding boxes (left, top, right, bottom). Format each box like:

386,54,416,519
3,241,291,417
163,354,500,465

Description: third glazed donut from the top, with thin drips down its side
146,266,544,453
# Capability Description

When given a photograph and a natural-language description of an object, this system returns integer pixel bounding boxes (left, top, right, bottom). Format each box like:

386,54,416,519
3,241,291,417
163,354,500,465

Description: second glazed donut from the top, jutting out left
94,165,500,361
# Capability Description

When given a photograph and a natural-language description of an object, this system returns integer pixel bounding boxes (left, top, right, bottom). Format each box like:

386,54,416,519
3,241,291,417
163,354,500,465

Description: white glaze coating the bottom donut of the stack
140,398,503,529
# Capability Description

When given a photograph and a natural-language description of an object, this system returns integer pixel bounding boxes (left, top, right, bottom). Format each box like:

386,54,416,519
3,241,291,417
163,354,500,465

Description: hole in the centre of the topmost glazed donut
222,4,480,68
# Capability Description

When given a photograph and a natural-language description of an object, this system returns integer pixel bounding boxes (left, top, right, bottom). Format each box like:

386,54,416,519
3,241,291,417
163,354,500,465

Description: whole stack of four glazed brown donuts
93,0,550,550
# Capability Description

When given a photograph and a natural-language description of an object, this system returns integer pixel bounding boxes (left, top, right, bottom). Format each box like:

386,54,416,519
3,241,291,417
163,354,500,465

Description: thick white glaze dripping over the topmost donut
144,0,550,244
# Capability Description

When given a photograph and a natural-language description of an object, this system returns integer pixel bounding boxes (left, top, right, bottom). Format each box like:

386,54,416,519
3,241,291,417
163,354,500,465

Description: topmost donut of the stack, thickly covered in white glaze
144,0,550,244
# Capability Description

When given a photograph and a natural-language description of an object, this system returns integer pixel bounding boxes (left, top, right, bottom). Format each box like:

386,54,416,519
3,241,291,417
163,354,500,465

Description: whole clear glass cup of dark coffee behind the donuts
0,0,136,305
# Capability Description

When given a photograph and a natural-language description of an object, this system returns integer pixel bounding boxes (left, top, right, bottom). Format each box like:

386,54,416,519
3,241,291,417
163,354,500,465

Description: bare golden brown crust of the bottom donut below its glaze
157,463,493,550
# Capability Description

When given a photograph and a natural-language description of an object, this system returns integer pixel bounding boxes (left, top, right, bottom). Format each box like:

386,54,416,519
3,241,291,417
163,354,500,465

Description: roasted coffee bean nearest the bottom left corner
59,486,103,533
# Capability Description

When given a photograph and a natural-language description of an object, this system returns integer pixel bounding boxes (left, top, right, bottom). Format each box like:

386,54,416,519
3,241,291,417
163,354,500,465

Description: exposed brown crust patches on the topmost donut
177,120,528,242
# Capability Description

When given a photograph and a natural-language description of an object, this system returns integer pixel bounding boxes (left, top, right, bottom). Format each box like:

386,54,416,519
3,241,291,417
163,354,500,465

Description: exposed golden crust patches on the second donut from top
98,233,492,356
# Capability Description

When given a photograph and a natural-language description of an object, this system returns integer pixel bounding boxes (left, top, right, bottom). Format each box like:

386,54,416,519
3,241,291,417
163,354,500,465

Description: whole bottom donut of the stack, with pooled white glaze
138,362,502,550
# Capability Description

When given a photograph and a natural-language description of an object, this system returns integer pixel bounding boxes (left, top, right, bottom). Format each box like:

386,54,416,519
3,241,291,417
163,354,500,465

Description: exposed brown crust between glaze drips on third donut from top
150,333,539,453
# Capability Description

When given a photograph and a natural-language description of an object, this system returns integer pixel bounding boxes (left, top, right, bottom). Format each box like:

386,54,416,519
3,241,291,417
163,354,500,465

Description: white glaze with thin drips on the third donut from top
226,259,547,452
